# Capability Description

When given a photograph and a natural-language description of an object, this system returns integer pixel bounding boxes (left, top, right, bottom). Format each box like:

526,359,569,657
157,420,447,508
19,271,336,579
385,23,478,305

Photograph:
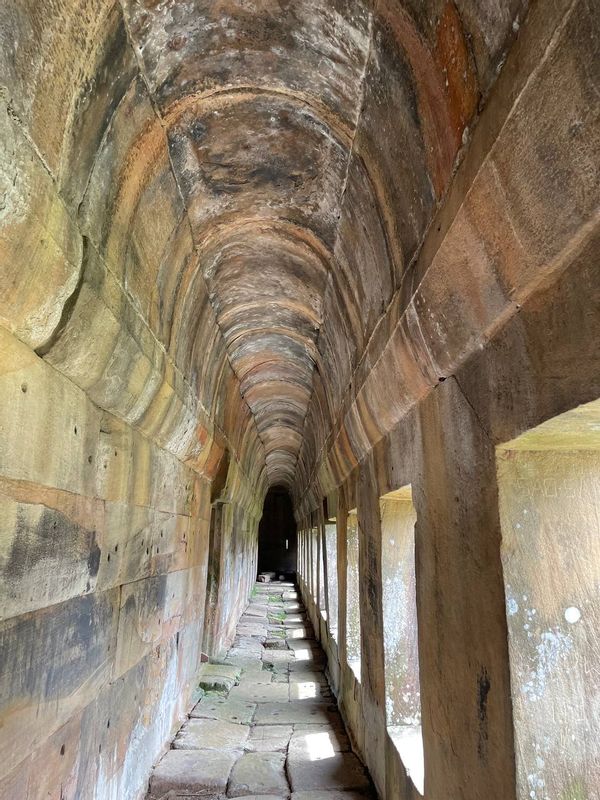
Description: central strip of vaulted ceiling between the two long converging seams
126,0,370,485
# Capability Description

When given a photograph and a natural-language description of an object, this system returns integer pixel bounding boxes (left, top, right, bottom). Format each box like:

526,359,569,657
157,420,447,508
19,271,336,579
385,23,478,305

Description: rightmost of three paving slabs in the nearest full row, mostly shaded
288,753,370,792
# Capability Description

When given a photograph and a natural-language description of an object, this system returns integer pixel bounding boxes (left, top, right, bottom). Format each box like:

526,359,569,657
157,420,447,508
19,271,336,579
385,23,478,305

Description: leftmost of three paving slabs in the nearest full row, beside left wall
150,750,242,798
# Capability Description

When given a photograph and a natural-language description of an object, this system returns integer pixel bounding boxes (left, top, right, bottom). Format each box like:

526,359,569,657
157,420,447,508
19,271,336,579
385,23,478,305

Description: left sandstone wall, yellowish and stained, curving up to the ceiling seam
0,1,266,800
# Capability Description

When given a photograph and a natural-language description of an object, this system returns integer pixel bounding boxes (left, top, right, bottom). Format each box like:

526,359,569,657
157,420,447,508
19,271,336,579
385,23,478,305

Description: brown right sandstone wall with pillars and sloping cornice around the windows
297,3,600,800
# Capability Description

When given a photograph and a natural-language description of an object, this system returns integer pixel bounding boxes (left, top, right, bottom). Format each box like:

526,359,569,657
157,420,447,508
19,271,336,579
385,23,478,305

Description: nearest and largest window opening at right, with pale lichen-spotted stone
496,400,600,800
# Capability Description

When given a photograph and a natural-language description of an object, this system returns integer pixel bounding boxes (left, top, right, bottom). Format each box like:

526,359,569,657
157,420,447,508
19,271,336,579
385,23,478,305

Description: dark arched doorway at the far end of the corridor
258,486,297,577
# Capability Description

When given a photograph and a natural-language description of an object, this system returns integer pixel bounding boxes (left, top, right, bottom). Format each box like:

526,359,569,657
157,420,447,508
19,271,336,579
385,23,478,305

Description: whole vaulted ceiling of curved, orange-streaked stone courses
2,0,527,501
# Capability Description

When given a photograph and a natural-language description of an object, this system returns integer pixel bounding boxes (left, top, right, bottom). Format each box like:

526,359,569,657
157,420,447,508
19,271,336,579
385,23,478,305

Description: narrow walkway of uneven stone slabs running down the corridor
149,583,374,800
